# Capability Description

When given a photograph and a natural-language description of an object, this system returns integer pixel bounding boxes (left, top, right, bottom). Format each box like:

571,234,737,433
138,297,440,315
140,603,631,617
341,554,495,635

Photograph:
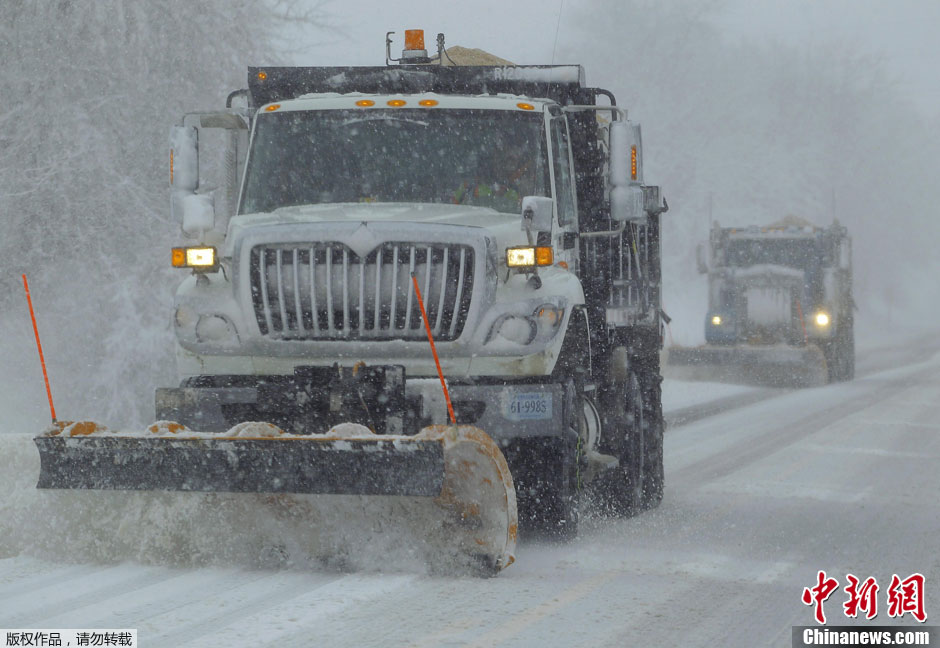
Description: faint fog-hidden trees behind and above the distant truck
562,0,940,343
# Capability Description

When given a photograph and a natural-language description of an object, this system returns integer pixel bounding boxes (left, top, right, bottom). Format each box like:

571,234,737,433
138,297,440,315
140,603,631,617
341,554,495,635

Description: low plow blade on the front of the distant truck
666,344,827,387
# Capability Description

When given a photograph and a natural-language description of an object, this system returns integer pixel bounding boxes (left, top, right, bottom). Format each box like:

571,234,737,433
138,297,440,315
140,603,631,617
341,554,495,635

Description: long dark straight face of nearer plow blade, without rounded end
36,435,444,497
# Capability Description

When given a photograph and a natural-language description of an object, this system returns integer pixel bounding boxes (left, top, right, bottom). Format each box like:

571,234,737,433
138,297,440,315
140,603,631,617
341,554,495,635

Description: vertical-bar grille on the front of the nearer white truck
250,242,474,341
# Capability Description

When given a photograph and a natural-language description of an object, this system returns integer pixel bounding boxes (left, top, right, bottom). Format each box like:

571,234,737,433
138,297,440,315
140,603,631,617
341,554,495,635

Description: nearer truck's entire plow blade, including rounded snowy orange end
34,422,518,574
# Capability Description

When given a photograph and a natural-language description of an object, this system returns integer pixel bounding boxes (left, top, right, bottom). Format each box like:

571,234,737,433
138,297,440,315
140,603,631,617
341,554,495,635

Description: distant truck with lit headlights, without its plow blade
705,216,854,381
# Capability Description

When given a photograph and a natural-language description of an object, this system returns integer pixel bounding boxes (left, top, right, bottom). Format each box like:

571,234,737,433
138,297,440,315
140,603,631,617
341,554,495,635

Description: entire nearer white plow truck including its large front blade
36,31,665,571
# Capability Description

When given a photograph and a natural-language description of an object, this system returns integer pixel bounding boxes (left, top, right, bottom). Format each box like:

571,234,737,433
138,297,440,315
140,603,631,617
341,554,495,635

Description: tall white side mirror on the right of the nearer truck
609,119,646,223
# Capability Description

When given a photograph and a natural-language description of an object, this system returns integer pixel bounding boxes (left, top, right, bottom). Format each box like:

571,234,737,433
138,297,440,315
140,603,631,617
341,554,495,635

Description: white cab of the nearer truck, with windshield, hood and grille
177,93,584,377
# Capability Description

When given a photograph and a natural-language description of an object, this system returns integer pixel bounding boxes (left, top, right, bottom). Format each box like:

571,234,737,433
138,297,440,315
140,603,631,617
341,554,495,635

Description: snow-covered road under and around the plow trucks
0,355,940,647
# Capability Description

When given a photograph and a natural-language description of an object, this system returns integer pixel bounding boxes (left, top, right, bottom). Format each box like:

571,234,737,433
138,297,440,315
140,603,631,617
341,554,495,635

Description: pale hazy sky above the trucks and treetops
288,0,940,116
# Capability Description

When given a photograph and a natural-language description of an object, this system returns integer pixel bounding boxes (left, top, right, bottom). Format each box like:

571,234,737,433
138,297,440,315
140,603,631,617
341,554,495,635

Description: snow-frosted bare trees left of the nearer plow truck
0,0,323,423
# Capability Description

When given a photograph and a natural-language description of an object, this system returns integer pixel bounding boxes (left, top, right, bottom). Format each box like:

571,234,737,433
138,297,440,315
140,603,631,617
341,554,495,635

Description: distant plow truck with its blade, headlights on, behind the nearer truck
668,216,855,386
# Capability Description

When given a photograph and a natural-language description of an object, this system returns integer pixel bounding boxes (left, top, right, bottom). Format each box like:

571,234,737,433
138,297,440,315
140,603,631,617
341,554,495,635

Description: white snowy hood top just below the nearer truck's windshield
226,203,525,252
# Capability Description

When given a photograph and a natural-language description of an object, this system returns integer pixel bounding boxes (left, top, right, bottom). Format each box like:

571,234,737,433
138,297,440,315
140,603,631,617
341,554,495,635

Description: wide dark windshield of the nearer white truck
239,108,551,214
